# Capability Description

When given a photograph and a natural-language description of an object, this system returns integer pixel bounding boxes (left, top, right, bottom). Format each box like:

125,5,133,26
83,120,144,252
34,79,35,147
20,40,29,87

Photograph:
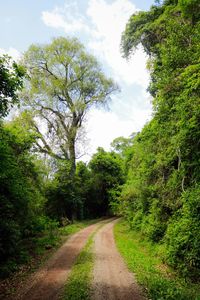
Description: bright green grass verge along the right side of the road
114,220,200,300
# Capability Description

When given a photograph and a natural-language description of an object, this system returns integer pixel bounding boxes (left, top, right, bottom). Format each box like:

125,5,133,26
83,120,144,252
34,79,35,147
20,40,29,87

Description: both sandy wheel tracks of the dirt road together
9,219,144,300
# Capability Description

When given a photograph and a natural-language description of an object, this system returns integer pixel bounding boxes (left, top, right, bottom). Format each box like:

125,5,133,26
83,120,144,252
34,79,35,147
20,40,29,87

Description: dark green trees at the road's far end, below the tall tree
46,148,124,221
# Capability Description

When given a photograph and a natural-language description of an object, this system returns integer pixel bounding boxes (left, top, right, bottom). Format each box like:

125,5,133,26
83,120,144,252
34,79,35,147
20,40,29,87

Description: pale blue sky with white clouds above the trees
0,0,154,161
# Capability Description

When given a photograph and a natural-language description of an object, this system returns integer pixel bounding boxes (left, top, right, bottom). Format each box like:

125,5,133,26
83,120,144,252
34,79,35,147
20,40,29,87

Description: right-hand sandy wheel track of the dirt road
92,220,144,300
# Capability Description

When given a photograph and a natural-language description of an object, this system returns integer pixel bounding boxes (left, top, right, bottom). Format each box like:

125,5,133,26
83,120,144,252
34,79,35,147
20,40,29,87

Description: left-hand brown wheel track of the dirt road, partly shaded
14,222,102,300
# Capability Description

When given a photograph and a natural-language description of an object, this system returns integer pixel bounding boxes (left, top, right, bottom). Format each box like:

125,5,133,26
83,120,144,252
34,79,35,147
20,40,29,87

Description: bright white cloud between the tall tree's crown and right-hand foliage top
42,0,149,88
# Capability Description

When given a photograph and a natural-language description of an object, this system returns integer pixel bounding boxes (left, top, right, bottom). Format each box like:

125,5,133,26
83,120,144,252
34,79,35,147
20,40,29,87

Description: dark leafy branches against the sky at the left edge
0,55,25,118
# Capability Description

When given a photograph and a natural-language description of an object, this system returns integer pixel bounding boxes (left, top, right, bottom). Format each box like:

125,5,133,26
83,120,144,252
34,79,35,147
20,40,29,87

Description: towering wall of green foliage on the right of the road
120,0,200,279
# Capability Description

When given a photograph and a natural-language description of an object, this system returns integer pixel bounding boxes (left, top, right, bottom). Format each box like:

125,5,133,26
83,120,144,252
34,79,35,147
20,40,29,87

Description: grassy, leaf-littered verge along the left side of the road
0,219,101,299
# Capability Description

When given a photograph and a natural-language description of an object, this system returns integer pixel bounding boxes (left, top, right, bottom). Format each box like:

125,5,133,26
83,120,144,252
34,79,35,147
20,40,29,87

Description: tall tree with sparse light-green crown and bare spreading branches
23,37,117,174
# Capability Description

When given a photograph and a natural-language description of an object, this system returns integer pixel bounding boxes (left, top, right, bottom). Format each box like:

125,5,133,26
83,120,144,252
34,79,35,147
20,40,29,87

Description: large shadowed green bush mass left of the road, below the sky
0,125,43,276
